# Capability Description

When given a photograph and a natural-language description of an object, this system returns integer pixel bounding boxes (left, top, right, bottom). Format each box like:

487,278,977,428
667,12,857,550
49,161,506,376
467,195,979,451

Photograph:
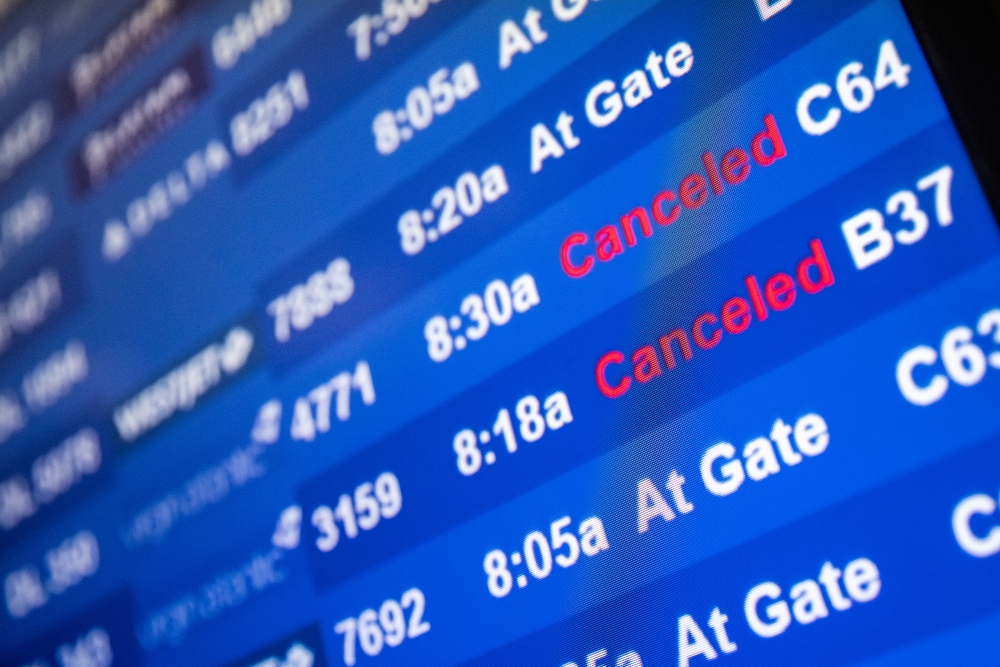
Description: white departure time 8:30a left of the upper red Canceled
424,273,541,363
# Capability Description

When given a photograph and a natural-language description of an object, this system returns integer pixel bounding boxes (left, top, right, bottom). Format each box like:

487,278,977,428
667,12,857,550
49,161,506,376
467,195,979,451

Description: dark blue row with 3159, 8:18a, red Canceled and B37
299,118,998,591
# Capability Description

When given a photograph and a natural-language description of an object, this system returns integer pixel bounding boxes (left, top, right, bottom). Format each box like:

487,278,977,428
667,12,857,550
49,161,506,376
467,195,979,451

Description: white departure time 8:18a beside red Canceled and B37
452,391,573,477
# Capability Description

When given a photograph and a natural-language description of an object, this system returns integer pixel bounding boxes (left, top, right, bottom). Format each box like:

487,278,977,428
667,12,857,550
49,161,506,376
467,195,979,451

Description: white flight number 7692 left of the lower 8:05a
333,588,431,667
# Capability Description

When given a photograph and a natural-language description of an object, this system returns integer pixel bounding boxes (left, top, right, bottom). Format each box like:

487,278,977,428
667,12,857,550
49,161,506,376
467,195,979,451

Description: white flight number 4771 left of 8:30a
291,360,375,442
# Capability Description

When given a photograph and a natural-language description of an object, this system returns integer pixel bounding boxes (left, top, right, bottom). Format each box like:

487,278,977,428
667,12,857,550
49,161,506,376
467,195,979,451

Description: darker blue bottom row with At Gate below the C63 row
452,428,1000,666
